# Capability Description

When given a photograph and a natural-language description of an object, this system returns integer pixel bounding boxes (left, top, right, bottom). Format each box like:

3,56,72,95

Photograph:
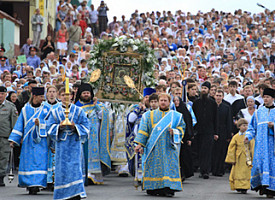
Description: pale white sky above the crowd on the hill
92,0,275,19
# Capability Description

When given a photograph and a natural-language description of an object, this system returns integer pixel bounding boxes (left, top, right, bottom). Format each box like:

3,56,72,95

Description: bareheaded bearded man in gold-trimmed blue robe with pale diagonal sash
135,93,185,197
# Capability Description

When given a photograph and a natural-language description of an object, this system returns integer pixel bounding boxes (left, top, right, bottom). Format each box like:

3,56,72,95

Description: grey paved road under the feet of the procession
0,174,266,200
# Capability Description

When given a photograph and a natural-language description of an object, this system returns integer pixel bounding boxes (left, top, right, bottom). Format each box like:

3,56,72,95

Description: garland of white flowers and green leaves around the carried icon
88,36,157,96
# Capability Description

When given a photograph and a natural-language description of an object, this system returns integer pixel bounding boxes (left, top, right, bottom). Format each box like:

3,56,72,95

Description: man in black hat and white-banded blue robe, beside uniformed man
9,87,50,194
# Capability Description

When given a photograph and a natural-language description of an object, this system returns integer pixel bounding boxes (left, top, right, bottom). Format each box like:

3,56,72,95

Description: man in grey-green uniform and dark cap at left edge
0,86,18,187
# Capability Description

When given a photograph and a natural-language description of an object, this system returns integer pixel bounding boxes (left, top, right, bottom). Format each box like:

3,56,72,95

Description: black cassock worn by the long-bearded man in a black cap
193,97,218,174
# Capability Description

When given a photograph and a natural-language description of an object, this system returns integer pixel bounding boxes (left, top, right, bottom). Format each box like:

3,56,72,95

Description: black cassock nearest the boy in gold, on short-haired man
212,102,233,176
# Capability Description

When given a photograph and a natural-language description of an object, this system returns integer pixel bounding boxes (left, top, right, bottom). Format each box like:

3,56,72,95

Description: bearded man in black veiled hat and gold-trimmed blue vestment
75,83,111,185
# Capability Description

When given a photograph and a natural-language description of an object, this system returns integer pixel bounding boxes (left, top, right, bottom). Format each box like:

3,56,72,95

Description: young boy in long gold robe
225,118,255,194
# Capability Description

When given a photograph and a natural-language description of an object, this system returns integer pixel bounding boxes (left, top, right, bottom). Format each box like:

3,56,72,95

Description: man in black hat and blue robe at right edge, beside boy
245,88,275,198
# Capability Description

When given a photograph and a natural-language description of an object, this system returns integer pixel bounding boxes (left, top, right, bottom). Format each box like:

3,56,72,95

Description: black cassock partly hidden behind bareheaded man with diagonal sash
176,99,194,179
